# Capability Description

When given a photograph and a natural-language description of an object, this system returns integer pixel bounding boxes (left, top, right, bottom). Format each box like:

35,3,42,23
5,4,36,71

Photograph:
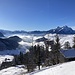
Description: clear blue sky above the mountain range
0,0,75,31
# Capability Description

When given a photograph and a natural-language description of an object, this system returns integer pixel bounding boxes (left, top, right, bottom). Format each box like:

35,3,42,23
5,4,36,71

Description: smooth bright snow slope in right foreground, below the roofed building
29,61,75,75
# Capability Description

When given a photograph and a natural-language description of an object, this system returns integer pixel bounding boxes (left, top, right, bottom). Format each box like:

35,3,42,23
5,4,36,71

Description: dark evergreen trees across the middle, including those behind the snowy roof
14,35,75,72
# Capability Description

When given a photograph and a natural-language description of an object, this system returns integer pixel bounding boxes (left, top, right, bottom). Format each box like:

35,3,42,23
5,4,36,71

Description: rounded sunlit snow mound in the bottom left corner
0,66,27,75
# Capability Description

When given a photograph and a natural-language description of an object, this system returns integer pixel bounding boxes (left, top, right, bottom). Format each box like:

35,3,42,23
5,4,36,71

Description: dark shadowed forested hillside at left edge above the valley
0,36,21,50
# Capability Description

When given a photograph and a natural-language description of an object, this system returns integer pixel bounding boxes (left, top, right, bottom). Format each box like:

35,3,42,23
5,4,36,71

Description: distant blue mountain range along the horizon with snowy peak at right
0,26,75,34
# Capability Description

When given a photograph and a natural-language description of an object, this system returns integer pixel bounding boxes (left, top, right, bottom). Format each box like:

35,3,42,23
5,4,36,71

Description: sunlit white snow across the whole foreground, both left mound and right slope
0,61,75,75
